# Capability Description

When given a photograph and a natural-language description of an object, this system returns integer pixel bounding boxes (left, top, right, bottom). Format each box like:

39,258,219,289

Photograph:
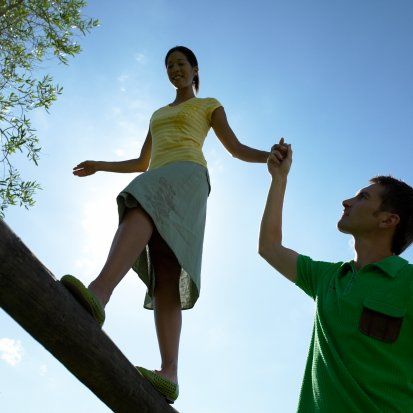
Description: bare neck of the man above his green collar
354,238,393,270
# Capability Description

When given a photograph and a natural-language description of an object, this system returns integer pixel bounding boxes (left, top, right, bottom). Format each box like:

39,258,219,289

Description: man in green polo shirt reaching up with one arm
259,139,413,413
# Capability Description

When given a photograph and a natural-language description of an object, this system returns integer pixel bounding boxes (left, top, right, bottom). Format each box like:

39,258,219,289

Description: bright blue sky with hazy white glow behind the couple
0,0,413,413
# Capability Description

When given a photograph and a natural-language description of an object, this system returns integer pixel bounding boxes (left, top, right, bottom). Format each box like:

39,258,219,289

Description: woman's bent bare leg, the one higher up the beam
89,208,153,306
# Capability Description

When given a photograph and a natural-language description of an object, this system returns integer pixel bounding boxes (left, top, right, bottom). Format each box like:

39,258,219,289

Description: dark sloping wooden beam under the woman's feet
0,219,176,413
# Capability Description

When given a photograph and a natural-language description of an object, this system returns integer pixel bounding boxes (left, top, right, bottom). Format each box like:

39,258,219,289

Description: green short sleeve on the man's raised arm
295,255,341,300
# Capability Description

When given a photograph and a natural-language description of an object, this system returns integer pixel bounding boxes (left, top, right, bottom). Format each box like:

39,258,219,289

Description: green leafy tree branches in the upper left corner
0,0,98,217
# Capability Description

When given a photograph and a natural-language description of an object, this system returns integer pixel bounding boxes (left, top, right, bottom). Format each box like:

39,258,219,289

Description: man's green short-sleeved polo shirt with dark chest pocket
296,255,413,413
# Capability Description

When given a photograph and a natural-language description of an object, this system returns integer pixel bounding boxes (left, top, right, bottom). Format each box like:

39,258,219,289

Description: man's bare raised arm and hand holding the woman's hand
258,138,298,282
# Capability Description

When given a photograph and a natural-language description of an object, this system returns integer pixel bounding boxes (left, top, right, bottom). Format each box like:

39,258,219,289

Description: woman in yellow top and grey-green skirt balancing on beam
61,46,269,403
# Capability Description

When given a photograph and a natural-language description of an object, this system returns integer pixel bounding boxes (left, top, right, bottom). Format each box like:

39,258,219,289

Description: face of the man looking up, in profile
337,184,386,235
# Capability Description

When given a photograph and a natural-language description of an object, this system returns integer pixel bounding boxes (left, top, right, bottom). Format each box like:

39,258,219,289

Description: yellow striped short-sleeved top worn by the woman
149,97,222,169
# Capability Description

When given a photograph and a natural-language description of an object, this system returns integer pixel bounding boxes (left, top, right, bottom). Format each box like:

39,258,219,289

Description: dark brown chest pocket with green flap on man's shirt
359,298,406,343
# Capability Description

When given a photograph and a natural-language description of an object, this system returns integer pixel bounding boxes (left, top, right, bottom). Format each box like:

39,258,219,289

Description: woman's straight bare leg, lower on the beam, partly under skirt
149,233,182,383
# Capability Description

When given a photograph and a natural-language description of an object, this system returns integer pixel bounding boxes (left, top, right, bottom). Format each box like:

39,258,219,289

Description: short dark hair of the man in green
370,176,413,255
